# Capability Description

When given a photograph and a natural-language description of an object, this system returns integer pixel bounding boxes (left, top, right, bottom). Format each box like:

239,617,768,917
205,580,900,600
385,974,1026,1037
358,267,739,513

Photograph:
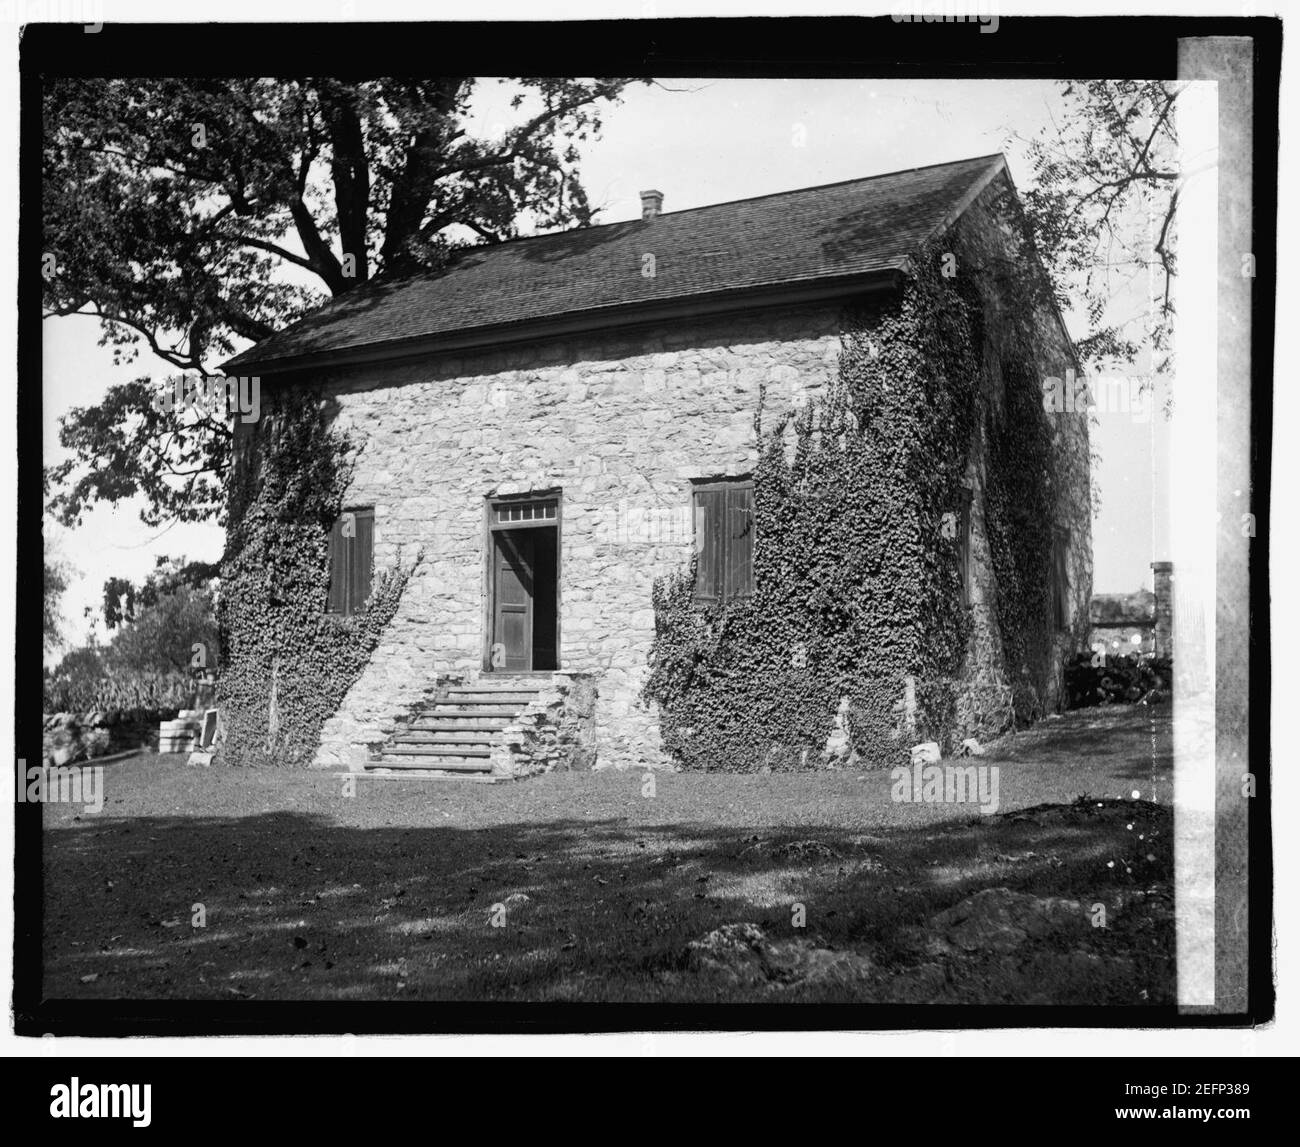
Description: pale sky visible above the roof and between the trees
43,79,1169,652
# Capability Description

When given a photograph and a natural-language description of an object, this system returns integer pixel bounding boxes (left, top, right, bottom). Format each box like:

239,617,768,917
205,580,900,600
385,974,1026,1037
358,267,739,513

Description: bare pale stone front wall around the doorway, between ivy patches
293,303,840,767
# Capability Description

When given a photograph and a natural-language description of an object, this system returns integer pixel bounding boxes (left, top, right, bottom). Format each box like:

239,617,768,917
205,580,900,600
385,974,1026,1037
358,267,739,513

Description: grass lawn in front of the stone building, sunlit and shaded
44,706,1174,1005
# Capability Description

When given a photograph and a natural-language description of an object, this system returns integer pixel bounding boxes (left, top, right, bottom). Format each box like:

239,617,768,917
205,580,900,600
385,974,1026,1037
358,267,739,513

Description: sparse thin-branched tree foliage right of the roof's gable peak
1023,79,1182,373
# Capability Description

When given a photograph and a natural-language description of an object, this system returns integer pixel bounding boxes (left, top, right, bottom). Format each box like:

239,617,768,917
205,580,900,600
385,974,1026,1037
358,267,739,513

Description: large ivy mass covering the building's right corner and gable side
645,189,1071,771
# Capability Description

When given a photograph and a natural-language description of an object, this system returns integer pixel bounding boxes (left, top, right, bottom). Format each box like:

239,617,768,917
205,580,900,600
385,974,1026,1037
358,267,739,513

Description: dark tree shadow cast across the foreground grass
44,801,1173,1004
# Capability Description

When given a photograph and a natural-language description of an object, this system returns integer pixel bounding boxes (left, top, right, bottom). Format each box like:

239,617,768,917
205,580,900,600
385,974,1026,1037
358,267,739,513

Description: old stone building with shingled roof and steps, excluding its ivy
228,156,1092,775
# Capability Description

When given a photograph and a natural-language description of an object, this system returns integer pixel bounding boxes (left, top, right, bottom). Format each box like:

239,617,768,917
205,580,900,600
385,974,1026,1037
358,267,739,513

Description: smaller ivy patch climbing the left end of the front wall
217,388,419,767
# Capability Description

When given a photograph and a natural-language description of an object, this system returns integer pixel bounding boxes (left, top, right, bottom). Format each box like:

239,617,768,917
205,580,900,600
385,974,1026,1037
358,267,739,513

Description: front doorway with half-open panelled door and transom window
484,492,560,674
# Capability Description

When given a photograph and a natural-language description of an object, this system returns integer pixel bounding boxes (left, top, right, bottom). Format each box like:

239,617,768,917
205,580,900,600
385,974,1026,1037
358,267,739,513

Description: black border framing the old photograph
10,16,1282,1036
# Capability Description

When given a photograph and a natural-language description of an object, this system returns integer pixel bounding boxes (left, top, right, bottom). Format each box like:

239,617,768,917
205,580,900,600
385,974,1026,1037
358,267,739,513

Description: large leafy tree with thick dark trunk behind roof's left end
43,77,642,525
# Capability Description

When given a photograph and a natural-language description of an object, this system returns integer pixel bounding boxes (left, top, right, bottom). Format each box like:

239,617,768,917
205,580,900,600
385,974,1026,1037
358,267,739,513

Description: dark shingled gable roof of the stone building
225,155,1005,373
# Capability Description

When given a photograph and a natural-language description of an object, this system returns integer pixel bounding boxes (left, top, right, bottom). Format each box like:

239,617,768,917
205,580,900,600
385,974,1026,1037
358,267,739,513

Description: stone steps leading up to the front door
365,676,545,782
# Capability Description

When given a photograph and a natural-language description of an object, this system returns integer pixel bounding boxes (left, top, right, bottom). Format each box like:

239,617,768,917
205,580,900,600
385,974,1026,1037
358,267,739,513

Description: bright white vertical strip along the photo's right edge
1170,81,1219,1008
